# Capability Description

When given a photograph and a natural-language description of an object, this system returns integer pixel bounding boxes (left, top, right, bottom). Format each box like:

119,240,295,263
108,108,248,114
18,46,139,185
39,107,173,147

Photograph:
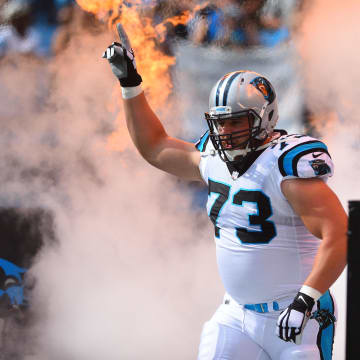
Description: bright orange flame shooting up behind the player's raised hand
76,0,194,151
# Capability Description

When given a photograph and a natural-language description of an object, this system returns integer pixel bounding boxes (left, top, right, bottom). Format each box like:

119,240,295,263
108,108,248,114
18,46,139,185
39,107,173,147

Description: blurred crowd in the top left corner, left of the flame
0,0,105,58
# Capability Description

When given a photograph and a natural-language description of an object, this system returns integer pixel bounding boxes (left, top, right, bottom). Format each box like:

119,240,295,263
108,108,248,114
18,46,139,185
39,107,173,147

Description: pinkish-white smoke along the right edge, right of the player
296,0,360,359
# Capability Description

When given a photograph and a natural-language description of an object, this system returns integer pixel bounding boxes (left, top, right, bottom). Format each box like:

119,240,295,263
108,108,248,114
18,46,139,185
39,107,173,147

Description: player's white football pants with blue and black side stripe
198,292,334,360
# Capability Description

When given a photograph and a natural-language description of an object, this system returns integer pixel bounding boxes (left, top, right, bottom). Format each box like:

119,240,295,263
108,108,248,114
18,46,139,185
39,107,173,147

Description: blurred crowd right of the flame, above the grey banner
155,0,304,49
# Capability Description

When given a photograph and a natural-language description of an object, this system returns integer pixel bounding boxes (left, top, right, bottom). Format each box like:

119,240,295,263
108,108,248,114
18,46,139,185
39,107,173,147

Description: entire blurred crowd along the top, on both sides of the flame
0,0,302,58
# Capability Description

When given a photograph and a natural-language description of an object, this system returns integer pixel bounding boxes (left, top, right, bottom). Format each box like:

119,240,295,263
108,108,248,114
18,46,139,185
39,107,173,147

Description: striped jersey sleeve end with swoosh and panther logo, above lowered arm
278,139,334,179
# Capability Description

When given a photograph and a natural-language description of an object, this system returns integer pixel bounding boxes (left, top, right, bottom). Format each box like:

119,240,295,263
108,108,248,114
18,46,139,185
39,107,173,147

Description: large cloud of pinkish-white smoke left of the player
0,26,222,360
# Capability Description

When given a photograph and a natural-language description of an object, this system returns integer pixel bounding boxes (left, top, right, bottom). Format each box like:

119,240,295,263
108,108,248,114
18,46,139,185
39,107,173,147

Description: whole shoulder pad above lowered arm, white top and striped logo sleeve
273,135,334,178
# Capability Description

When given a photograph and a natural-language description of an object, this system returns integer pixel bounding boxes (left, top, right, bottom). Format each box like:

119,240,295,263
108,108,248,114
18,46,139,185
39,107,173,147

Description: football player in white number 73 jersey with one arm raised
103,35,347,360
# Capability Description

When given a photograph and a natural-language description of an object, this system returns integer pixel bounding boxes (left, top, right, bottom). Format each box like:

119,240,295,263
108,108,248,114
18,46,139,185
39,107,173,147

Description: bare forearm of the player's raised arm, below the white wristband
124,93,167,163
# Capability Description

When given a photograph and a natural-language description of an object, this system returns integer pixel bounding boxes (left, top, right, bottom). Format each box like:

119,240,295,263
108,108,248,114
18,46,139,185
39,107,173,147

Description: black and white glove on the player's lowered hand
276,292,315,345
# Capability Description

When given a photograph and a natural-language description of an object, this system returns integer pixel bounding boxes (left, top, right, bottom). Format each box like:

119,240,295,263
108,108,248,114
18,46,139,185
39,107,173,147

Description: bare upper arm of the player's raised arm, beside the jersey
150,136,202,181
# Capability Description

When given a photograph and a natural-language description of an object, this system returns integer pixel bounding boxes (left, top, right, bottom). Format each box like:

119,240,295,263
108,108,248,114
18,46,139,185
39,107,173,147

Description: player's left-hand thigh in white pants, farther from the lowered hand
198,320,270,360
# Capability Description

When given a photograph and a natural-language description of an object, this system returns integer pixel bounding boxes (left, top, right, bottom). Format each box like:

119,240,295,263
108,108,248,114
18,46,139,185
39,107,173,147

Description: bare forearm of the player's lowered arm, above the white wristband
304,233,347,293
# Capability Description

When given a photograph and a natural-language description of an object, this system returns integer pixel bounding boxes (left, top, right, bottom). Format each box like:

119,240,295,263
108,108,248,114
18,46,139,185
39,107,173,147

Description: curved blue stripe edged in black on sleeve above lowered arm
279,140,328,176
